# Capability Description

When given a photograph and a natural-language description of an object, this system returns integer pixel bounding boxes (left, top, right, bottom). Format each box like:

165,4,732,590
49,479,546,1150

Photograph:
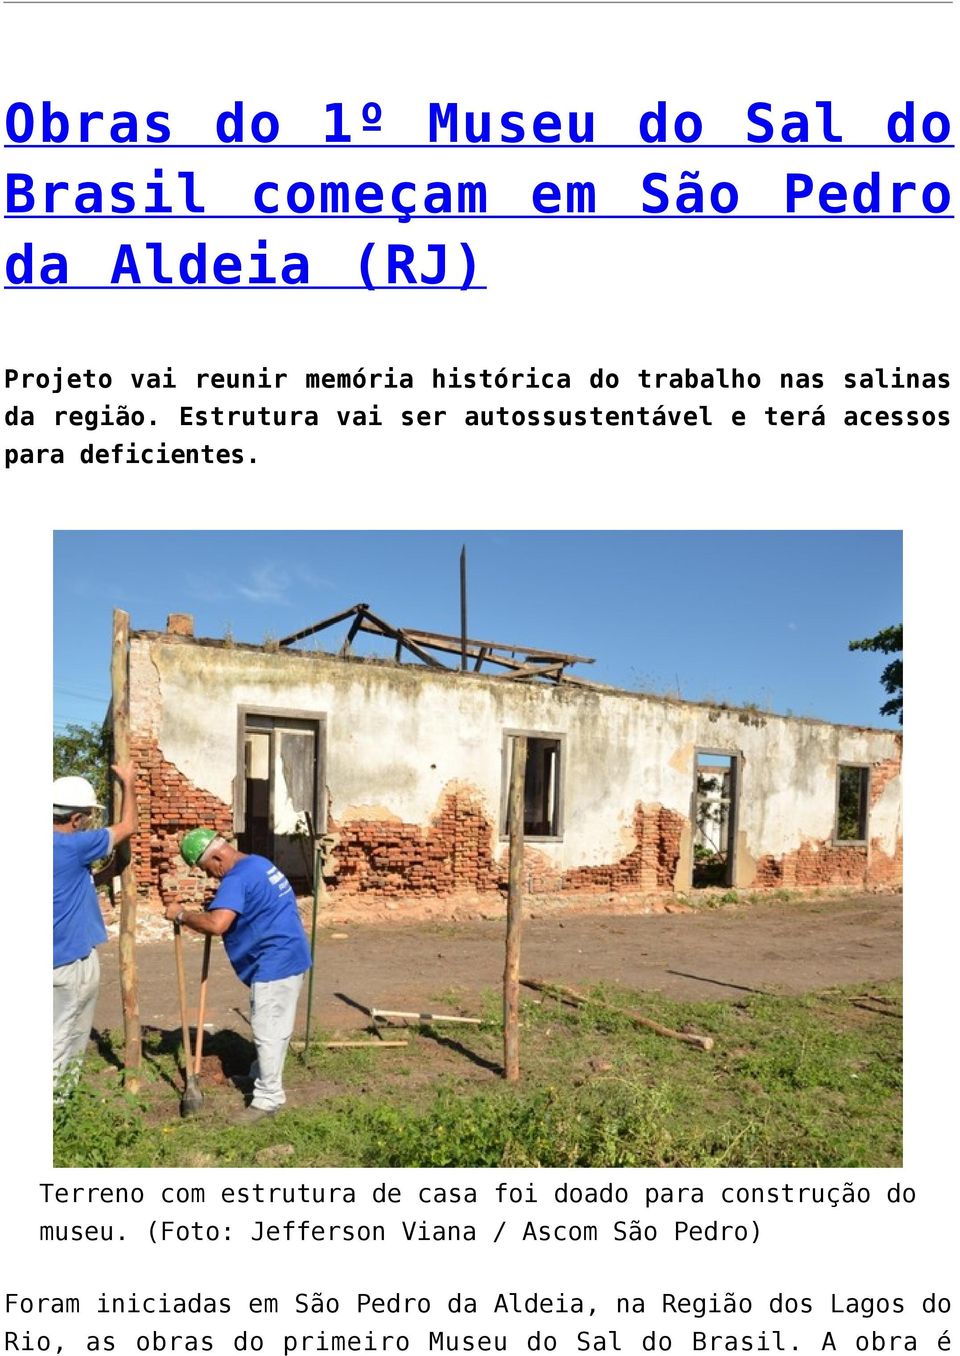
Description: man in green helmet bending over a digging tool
165,829,311,1125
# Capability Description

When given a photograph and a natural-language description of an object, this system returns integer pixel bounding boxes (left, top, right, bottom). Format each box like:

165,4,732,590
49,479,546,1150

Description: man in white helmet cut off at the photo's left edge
53,762,137,1092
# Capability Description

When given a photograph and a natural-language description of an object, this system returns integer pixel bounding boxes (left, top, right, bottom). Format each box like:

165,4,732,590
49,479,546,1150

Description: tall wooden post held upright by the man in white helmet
110,607,141,1093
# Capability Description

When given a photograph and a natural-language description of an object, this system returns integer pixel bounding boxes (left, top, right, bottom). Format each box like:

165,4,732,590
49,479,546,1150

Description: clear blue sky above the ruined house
54,532,902,728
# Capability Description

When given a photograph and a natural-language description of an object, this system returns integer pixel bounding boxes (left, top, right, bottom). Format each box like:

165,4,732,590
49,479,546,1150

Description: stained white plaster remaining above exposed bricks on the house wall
132,636,900,868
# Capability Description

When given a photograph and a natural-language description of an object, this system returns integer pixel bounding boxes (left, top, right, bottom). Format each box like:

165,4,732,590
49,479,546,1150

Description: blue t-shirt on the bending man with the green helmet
207,857,311,984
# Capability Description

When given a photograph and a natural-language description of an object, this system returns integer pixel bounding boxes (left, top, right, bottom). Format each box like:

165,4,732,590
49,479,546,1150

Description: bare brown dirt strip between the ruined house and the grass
96,894,902,1036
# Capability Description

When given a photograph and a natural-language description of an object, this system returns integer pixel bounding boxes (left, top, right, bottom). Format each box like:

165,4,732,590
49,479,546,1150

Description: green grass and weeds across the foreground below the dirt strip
54,984,902,1168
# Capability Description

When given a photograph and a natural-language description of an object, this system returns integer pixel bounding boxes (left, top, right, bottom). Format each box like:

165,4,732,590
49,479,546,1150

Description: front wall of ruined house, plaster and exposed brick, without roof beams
130,632,902,898
